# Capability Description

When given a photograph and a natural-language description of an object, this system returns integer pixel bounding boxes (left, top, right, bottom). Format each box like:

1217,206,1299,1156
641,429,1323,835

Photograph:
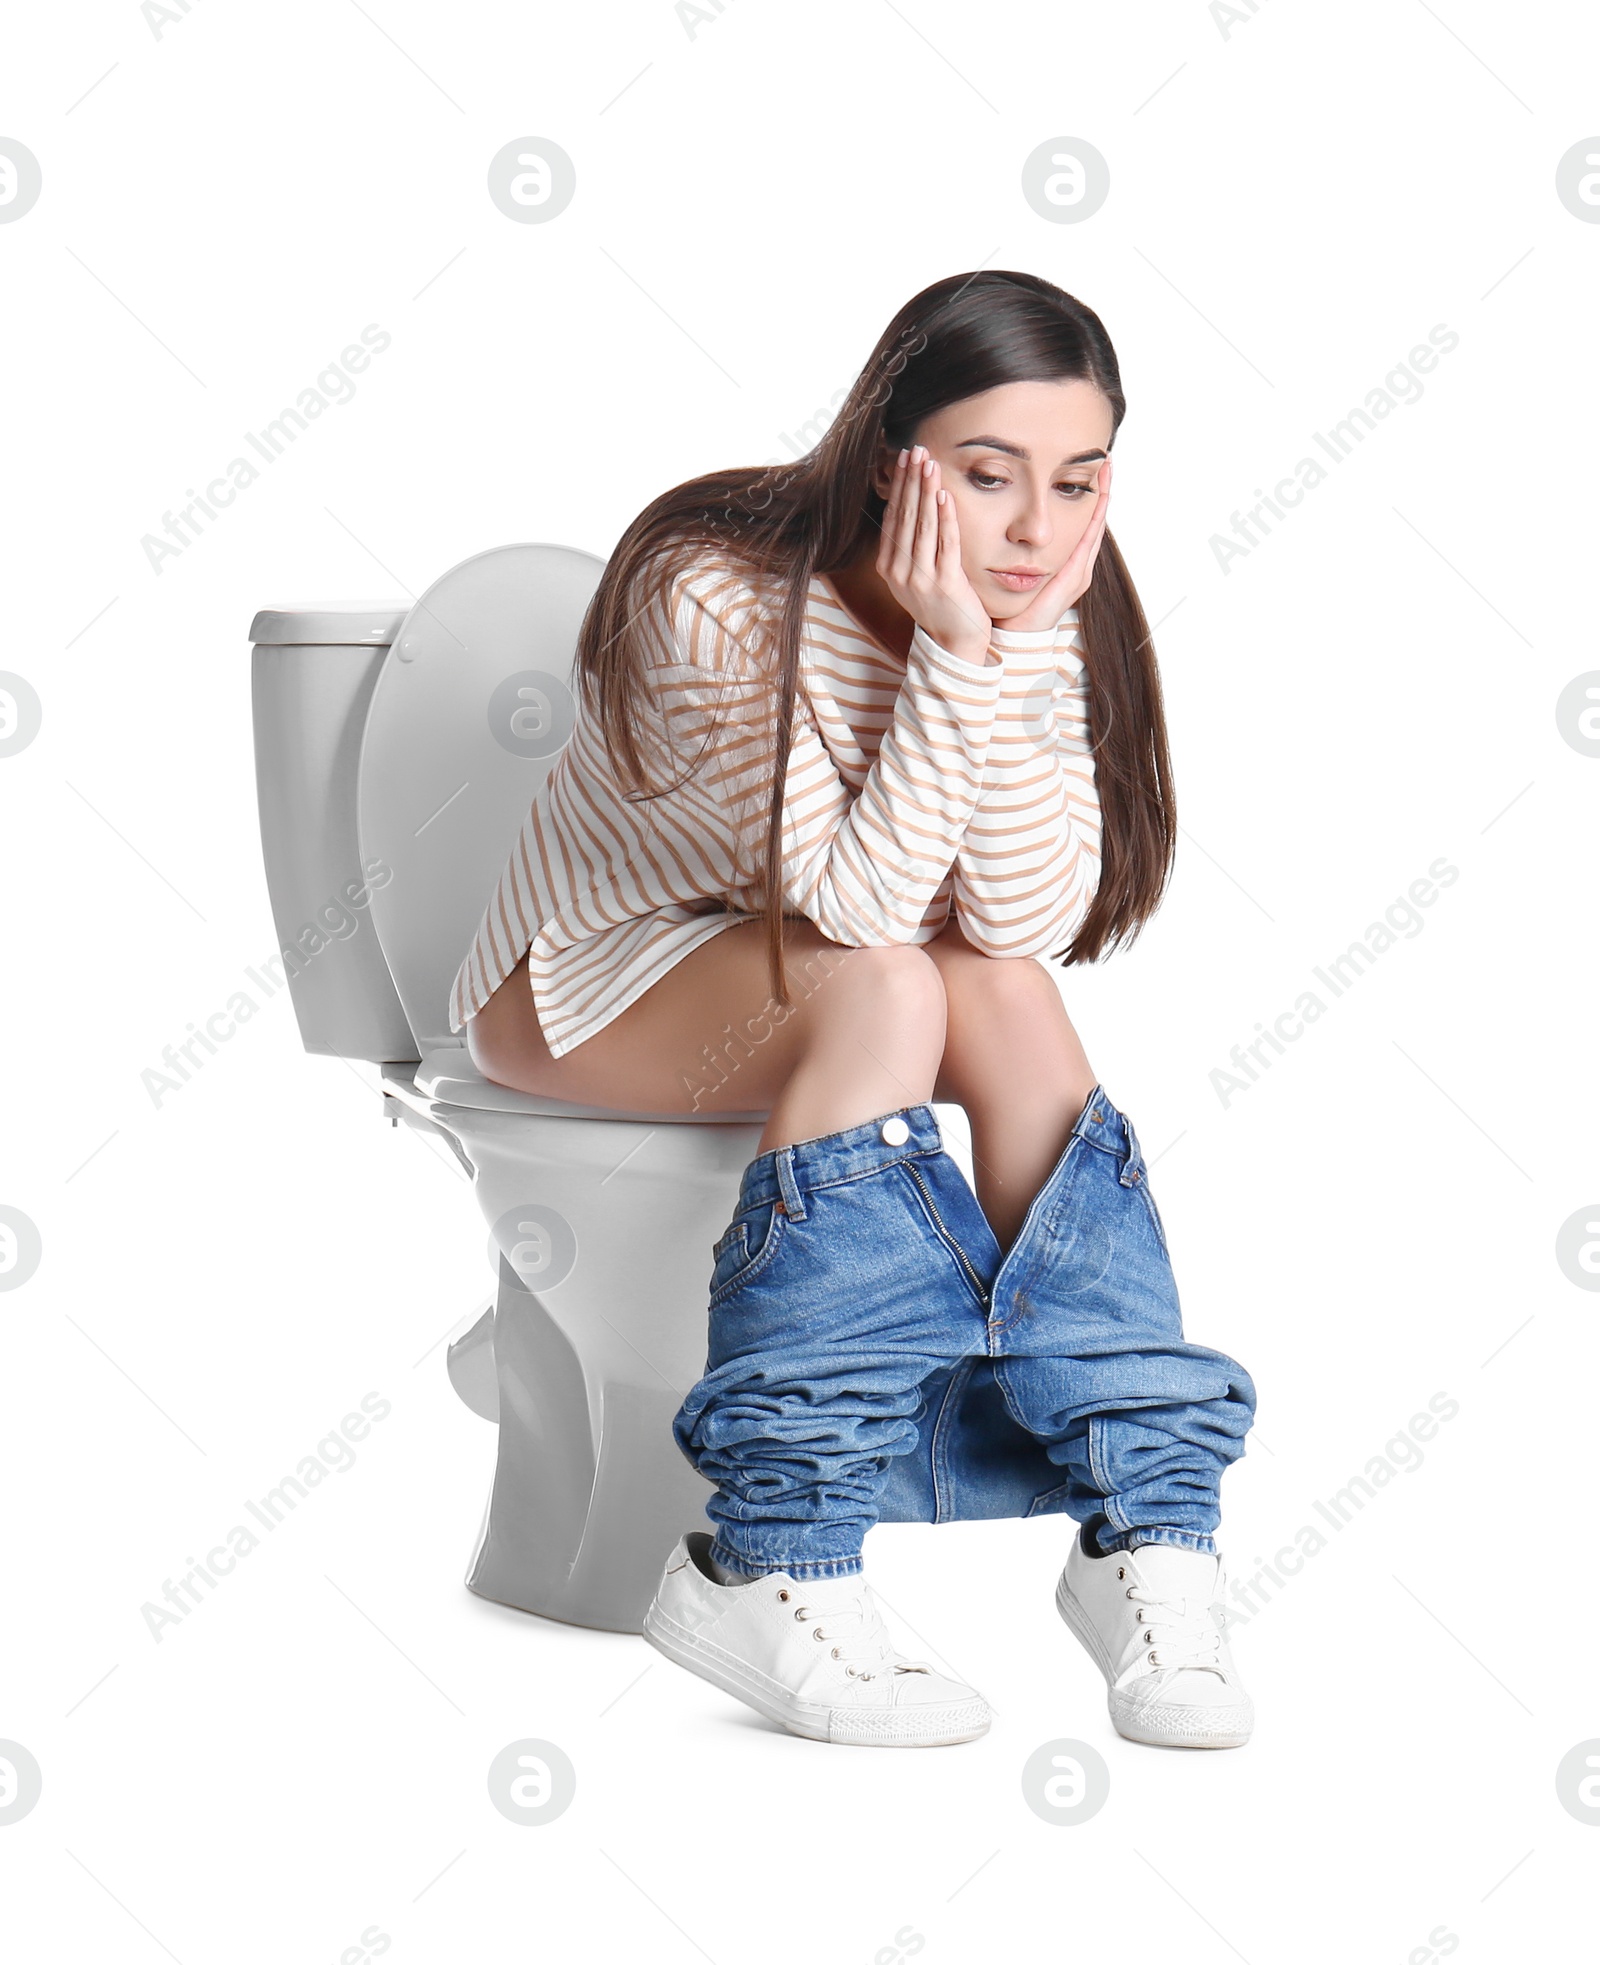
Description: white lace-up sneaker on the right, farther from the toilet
1056,1533,1256,1747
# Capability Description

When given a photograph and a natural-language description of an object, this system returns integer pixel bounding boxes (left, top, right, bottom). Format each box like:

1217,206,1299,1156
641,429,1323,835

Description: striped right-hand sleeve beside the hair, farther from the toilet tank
953,607,1101,955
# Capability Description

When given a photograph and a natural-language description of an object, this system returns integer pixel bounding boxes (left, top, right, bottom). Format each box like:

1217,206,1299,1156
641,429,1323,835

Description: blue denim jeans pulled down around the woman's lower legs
672,1085,1256,1578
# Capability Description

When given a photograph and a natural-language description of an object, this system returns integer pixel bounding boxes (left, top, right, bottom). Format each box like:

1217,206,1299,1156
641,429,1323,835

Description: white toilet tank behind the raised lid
250,599,421,1065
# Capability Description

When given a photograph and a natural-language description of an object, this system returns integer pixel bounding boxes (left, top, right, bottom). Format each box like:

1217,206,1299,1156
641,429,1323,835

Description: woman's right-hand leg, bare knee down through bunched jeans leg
908,929,1254,1552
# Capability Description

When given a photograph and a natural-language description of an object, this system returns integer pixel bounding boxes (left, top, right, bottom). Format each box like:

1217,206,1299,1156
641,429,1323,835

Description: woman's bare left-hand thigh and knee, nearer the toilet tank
466,918,945,1150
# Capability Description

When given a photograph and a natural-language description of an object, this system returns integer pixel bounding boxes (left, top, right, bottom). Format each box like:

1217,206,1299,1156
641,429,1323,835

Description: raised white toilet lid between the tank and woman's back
356,544,605,1057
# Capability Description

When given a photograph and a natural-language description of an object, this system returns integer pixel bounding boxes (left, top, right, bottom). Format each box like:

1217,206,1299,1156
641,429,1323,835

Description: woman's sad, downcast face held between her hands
873,381,1113,621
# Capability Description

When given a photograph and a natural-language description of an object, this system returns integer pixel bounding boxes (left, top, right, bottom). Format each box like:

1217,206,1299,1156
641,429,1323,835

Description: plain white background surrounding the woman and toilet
0,0,1600,1965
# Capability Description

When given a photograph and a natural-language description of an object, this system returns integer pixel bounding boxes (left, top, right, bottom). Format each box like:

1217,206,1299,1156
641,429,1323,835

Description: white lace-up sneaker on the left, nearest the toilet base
645,1529,991,1747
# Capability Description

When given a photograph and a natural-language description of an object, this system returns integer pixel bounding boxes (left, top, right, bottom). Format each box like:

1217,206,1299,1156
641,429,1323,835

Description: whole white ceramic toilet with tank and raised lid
250,544,782,1631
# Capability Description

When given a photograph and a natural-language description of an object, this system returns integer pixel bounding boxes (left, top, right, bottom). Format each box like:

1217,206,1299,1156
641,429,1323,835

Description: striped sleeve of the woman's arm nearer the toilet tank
657,558,1006,947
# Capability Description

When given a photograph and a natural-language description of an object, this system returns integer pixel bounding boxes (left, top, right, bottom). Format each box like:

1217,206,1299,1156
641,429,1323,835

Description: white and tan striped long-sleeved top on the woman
450,550,1101,1057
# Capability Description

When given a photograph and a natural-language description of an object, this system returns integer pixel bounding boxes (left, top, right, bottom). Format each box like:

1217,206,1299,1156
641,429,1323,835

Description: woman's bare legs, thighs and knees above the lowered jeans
466,916,1095,1210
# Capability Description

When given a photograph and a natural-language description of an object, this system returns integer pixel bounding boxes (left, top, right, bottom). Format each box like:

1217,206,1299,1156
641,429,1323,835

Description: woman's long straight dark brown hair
576,271,1177,1004
